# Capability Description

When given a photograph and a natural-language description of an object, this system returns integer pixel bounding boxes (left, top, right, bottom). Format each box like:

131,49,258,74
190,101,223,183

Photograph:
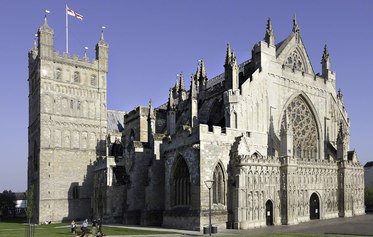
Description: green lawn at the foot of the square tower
0,222,179,237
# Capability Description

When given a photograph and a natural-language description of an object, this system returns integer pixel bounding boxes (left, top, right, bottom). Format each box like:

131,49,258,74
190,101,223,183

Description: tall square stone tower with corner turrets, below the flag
28,18,108,223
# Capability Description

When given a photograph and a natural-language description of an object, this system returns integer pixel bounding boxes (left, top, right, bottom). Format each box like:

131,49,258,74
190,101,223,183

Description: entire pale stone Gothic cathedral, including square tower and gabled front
28,15,364,230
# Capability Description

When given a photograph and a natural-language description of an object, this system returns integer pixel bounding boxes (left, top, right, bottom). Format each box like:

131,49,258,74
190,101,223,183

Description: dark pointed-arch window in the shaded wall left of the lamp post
170,156,191,206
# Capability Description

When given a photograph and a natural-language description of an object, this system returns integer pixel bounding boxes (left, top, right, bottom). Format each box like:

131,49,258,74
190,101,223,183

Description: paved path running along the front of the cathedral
106,213,373,237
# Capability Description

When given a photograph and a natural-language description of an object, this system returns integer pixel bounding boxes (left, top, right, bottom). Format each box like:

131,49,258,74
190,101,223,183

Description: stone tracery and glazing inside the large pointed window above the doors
281,96,318,158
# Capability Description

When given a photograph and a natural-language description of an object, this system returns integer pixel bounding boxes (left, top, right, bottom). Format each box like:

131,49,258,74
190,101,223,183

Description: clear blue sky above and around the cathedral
0,0,373,191
